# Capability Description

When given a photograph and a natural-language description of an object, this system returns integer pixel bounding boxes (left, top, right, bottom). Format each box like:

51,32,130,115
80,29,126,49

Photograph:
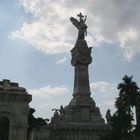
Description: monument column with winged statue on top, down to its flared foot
70,13,95,106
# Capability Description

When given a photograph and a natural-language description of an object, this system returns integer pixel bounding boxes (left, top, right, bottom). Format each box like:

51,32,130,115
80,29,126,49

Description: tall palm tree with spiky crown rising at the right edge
118,75,139,127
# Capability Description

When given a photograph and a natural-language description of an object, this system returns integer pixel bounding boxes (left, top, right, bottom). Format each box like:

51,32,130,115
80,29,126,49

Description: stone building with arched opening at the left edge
0,80,31,140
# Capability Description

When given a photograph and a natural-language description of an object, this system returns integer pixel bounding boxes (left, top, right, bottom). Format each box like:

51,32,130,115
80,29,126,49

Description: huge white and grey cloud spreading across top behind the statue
11,0,140,60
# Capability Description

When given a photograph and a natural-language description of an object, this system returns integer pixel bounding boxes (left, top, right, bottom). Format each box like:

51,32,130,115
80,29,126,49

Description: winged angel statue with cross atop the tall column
70,13,87,40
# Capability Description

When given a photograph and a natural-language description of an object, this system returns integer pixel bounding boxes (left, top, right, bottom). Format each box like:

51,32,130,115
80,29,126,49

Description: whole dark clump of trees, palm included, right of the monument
101,75,140,140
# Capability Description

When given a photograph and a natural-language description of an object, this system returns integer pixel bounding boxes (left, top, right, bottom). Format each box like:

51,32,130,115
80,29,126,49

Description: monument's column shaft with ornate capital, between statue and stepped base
71,39,92,97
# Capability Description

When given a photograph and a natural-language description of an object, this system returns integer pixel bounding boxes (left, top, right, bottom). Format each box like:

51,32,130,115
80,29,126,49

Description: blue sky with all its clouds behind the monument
0,0,140,118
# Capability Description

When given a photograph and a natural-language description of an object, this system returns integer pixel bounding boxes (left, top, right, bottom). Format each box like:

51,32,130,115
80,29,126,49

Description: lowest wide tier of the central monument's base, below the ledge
50,122,107,140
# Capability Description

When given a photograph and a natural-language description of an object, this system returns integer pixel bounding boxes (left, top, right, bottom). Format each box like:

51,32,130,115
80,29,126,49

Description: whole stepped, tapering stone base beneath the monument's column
49,93,109,140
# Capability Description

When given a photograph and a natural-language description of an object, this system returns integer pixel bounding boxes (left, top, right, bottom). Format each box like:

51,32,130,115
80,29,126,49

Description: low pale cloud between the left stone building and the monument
28,85,70,118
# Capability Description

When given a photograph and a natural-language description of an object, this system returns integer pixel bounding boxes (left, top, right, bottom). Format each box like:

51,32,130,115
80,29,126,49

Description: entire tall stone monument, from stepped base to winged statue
49,13,109,140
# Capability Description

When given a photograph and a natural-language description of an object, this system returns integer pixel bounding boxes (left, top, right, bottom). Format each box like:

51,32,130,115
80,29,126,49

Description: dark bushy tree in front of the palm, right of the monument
111,94,133,140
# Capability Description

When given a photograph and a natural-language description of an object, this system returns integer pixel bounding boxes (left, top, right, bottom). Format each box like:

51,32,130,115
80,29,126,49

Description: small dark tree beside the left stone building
27,108,47,140
